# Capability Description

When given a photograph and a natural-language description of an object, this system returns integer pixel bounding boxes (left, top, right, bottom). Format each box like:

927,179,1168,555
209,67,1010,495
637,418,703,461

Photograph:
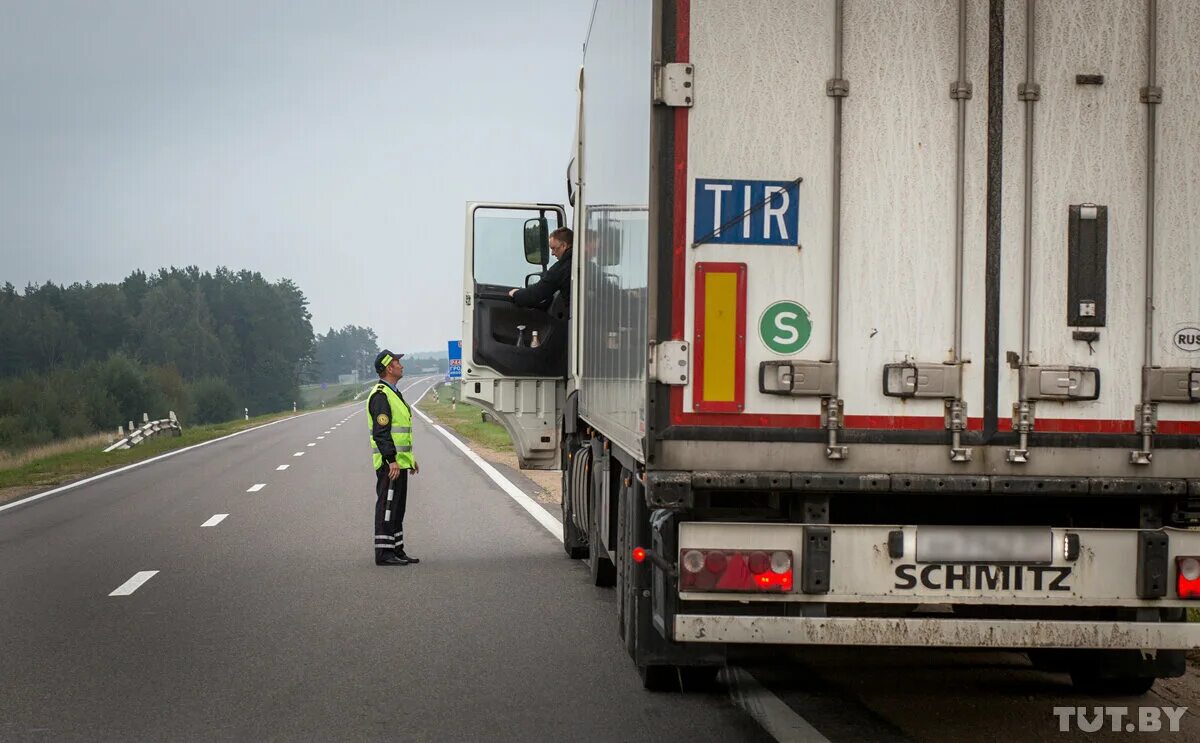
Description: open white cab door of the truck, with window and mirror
462,202,569,469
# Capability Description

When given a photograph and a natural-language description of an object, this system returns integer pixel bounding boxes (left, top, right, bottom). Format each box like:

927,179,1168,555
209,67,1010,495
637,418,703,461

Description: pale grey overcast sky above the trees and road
0,0,593,350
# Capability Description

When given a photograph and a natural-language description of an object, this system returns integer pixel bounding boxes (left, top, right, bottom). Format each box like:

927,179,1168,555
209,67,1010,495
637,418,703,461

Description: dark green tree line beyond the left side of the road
0,266,374,448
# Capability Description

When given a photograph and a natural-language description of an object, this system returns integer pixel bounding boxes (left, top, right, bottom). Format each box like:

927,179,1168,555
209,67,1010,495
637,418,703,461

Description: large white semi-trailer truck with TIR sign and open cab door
461,0,1200,694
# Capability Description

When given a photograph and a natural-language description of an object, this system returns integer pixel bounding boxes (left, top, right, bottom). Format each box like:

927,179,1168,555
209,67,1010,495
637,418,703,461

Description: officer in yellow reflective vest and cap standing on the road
367,349,421,565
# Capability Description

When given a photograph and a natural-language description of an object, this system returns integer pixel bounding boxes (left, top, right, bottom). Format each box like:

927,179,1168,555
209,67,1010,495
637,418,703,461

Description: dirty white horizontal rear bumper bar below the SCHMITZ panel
673,615,1200,649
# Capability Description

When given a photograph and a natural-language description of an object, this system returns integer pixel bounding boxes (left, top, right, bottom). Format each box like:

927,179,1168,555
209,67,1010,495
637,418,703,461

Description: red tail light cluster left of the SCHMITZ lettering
679,549,792,593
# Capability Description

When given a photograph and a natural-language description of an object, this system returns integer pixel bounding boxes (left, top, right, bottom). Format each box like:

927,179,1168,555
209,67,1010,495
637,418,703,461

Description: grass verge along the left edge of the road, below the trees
0,411,314,502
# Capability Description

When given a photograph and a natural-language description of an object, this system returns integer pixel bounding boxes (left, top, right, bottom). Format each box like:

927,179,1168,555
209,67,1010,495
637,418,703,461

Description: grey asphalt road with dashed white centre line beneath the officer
0,381,769,741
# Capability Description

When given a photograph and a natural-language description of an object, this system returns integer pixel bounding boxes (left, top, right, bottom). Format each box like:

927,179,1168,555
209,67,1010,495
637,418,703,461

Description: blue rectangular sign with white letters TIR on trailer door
692,178,800,245
